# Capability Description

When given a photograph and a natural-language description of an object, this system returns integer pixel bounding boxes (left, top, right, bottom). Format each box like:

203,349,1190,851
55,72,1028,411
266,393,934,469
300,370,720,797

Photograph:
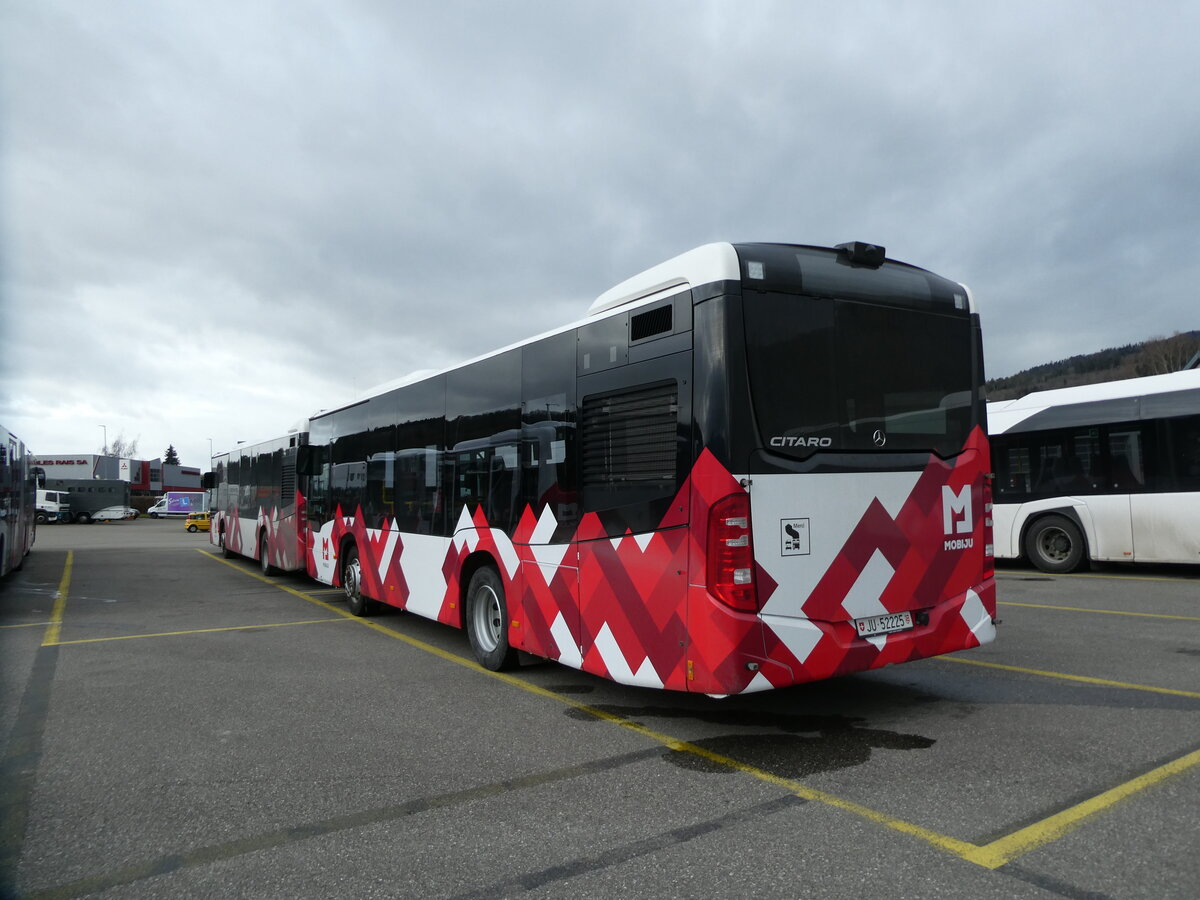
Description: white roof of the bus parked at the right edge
988,368,1200,434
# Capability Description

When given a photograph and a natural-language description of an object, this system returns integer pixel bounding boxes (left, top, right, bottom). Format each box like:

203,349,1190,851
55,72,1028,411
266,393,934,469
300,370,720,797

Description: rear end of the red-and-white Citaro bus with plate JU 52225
689,245,995,694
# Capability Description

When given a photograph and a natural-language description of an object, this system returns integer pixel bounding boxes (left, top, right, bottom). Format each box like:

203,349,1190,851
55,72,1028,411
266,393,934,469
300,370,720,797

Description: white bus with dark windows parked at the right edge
988,368,1200,572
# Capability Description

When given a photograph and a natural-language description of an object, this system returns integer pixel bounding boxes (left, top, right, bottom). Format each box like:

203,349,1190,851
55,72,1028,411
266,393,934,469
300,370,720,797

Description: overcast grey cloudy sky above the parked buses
0,0,1200,468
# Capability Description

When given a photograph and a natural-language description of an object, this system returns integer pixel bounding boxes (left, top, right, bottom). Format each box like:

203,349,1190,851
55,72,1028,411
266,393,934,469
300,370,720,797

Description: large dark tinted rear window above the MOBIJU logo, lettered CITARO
744,293,977,458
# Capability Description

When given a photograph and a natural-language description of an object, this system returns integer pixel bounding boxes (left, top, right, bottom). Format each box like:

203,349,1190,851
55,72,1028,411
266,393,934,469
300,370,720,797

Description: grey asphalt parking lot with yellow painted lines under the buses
0,520,1200,900
